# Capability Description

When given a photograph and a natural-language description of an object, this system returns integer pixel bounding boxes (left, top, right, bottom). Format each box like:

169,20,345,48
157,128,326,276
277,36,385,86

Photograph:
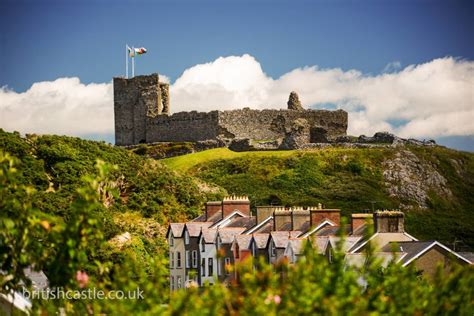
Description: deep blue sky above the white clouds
0,0,474,150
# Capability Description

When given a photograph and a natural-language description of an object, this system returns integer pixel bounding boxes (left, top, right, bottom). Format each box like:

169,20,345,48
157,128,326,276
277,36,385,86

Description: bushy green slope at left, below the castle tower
0,129,207,262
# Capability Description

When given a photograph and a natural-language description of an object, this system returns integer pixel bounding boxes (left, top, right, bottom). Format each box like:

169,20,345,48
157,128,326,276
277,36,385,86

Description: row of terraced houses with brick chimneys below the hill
166,196,473,290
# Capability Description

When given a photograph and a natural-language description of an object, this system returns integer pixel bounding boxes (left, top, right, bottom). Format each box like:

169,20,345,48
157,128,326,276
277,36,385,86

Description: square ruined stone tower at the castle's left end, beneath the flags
114,74,170,145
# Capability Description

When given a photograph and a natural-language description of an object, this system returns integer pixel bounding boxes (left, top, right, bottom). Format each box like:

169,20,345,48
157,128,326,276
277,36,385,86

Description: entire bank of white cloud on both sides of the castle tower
0,55,474,138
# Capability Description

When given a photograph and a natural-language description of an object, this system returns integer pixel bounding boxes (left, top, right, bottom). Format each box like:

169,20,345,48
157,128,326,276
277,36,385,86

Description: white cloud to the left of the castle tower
0,78,114,135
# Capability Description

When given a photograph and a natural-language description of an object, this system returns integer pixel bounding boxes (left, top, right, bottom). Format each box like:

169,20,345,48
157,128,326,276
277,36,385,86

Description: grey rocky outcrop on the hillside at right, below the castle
383,150,452,208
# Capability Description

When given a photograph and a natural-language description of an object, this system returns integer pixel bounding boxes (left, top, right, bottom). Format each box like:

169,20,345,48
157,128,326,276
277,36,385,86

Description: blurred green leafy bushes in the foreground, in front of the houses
0,149,474,315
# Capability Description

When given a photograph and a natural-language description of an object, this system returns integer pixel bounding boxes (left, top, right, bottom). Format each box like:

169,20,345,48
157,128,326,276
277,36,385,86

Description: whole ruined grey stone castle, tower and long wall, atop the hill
114,74,347,146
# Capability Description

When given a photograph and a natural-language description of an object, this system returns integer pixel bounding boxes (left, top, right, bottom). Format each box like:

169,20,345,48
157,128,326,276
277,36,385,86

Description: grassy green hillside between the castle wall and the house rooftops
163,147,474,249
